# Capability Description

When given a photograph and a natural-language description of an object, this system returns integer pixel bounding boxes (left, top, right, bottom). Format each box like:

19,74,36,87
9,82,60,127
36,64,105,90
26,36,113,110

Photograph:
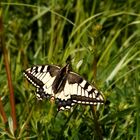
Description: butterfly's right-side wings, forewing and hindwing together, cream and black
57,72,104,110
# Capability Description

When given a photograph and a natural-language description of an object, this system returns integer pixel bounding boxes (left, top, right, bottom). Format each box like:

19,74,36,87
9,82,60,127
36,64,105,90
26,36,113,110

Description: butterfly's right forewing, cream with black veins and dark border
68,72,104,105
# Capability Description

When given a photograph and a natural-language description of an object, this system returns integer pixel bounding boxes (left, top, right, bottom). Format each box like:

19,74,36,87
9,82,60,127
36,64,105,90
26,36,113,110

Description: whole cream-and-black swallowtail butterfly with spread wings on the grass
24,64,104,110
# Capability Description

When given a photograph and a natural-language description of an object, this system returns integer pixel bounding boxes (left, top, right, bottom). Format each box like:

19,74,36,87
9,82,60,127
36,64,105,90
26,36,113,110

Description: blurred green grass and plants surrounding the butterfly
0,0,140,140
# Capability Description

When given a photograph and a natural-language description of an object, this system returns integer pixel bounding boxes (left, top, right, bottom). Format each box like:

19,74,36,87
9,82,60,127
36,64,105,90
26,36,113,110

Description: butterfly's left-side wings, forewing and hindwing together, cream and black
23,65,60,100
